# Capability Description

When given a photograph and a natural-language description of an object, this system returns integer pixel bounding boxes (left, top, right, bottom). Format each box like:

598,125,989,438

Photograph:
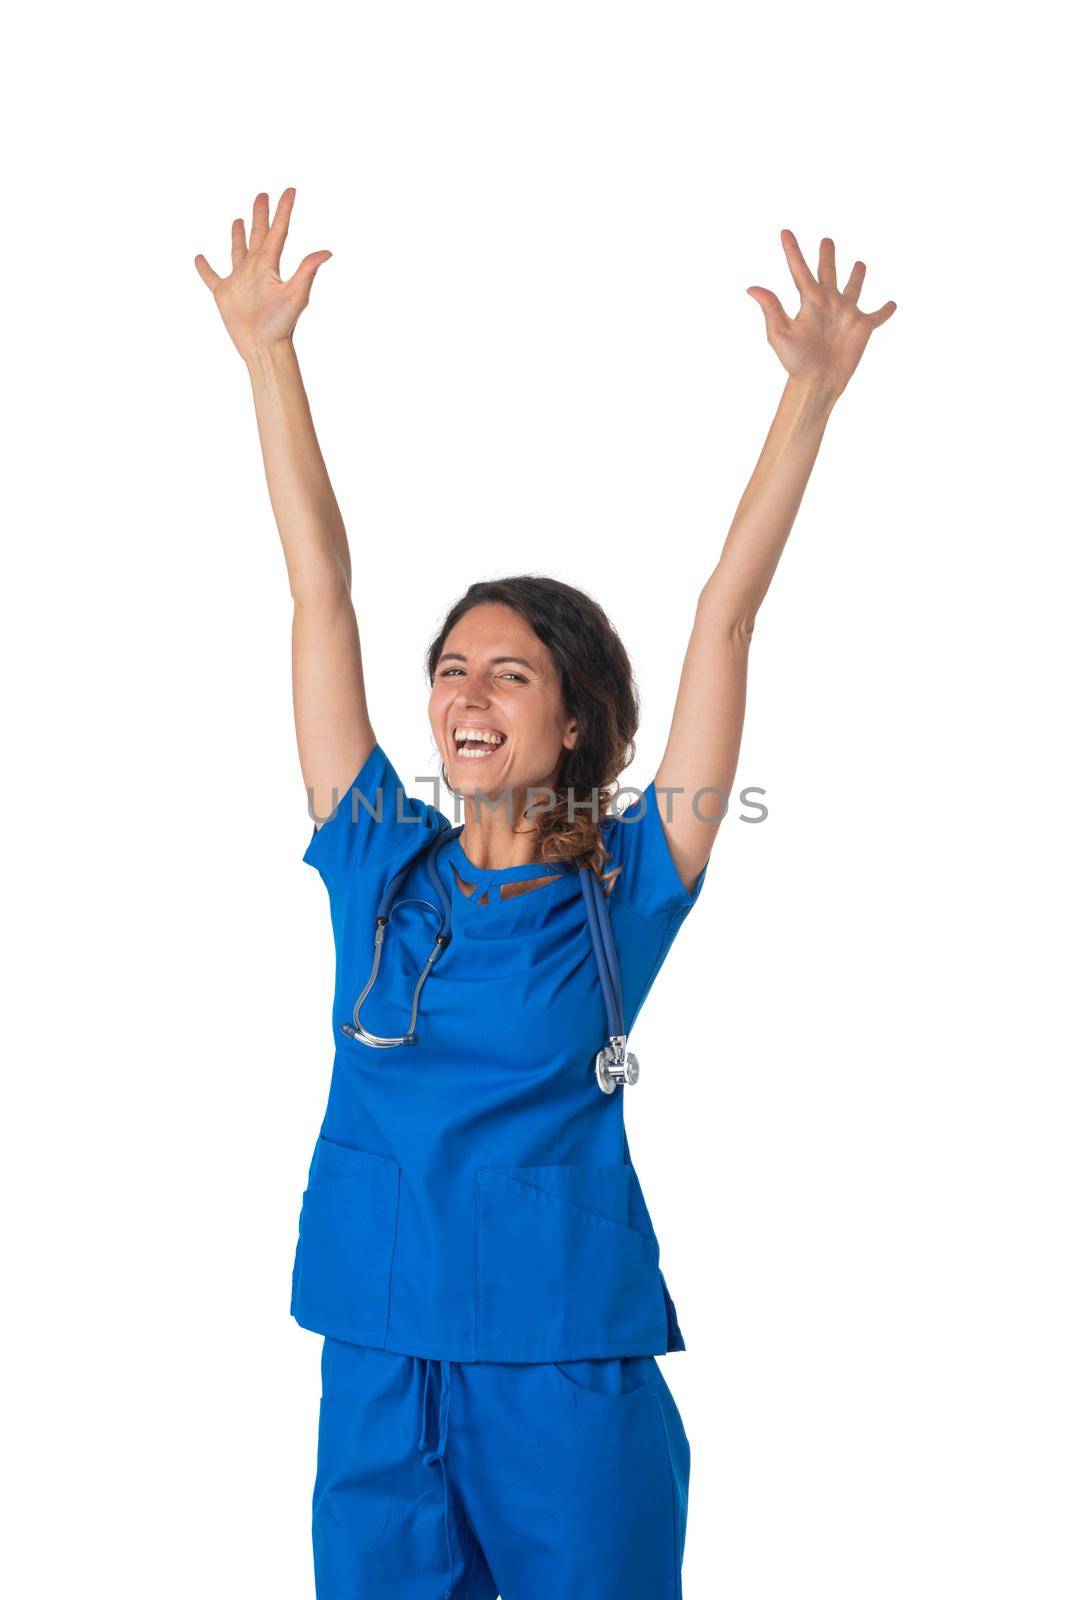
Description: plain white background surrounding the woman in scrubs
0,0,1067,1600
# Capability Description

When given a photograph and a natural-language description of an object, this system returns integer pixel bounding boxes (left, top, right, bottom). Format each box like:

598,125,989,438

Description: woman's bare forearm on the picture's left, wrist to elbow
245,339,352,603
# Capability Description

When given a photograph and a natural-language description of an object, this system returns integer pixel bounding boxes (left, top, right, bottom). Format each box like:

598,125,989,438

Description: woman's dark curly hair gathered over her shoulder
426,574,640,882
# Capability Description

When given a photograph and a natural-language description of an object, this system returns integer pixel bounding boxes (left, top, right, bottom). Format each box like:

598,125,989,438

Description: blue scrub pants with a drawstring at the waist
312,1339,689,1600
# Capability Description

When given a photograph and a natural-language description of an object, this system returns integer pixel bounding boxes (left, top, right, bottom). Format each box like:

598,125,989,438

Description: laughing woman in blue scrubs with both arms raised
195,189,896,1600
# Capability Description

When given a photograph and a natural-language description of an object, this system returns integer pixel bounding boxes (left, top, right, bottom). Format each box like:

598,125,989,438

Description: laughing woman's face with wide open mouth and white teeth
429,603,577,821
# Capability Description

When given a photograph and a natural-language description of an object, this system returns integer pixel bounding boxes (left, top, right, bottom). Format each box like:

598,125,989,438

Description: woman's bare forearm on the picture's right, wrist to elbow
699,378,837,637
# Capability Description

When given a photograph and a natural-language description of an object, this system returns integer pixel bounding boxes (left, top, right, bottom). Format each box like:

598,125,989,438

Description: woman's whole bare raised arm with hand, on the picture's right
656,229,896,888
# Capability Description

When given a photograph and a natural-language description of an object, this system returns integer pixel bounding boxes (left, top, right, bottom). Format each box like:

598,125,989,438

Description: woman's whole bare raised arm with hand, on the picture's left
195,189,374,821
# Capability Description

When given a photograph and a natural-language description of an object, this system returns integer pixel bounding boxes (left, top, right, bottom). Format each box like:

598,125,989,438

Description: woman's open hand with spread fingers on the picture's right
747,227,896,400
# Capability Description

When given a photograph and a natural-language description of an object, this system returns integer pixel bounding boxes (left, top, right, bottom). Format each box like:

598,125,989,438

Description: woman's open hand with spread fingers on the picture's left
194,189,333,363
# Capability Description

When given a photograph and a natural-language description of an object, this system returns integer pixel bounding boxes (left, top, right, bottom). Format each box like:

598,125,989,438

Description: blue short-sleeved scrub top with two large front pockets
291,744,707,1362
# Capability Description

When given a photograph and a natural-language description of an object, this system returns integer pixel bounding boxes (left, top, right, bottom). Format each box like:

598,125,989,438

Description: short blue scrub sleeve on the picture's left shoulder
304,744,450,894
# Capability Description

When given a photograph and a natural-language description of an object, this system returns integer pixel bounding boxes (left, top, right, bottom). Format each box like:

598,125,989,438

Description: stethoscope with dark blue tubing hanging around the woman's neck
341,824,640,1094
